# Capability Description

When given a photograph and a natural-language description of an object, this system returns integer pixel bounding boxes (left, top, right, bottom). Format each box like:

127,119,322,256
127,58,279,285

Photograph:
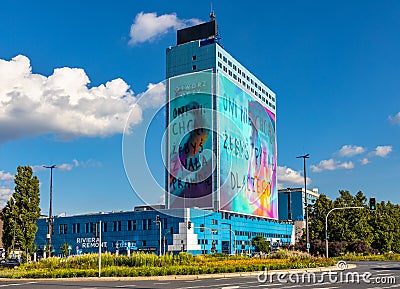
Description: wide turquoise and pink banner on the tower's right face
217,74,278,219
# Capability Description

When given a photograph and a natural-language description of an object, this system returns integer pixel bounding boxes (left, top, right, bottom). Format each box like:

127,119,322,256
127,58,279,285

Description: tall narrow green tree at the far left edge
0,166,40,258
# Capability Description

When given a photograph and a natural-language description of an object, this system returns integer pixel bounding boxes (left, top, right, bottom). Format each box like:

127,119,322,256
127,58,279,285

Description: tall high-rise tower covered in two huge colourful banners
166,18,278,219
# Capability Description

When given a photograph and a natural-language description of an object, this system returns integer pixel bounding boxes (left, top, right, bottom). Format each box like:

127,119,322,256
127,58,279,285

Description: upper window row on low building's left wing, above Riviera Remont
59,218,168,235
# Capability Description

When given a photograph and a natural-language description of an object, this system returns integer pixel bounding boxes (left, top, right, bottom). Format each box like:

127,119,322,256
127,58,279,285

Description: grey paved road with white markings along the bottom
0,262,400,289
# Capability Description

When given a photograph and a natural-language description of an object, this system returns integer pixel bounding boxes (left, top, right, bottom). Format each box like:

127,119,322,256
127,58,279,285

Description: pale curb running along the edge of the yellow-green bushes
0,264,357,282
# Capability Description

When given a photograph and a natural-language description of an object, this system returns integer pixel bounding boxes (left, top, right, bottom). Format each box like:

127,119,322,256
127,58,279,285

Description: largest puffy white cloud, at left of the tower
0,55,164,143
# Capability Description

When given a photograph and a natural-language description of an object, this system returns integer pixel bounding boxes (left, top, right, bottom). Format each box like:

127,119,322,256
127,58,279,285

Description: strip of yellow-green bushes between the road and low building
0,251,334,278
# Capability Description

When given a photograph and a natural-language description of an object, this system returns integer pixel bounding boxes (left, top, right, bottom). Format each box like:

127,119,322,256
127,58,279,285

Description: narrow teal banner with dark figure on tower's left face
167,70,213,208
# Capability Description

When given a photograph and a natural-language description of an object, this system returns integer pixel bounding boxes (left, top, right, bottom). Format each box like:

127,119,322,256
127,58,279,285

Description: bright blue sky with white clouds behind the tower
0,0,400,215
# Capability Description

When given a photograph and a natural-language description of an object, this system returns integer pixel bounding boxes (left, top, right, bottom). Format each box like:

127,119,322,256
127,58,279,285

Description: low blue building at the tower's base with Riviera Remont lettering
35,208,294,256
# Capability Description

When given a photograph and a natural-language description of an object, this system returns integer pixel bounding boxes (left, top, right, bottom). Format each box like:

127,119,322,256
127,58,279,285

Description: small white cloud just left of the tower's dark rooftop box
129,12,202,45
